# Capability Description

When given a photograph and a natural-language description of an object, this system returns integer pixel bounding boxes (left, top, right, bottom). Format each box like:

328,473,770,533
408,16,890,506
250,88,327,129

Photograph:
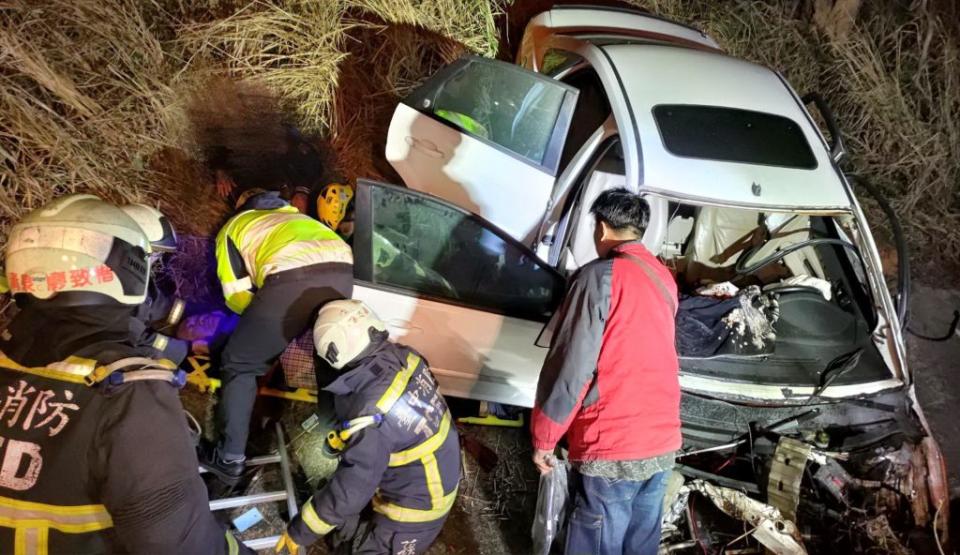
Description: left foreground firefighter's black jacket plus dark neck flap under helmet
0,302,252,555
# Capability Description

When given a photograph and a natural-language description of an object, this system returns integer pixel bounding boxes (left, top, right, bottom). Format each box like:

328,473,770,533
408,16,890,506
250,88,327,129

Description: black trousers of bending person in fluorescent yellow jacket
218,264,353,457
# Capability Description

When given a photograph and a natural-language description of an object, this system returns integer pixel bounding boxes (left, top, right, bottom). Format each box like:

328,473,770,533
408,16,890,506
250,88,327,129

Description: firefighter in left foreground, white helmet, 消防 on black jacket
0,195,251,554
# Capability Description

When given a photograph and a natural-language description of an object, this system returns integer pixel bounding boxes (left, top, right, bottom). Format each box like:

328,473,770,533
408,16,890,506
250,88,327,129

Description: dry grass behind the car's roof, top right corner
632,0,960,276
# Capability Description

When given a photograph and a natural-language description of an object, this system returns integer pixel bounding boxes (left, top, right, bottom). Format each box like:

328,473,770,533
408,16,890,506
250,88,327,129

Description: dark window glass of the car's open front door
368,186,564,320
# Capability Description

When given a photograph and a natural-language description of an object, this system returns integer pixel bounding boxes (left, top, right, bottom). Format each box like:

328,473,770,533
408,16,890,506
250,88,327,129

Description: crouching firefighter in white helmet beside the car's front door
277,301,460,555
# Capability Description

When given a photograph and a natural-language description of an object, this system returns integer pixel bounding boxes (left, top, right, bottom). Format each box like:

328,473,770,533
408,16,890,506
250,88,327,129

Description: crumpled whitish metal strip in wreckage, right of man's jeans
687,480,807,555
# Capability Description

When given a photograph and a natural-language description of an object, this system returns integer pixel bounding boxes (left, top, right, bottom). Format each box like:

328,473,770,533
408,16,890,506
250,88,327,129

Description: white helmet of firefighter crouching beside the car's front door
313,300,387,370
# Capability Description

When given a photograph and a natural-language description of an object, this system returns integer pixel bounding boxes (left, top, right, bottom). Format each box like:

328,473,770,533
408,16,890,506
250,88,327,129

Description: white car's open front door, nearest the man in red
353,180,564,407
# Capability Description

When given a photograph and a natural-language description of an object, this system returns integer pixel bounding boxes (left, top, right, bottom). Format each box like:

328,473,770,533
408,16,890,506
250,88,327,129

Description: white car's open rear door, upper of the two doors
386,56,578,245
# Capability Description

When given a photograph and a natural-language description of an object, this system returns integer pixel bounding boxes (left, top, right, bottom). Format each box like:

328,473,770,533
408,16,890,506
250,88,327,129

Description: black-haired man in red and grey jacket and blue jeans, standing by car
531,189,681,555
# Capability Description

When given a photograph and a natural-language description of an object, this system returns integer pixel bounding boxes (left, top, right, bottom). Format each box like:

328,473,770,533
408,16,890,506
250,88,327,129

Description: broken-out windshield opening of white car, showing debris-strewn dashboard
661,203,890,388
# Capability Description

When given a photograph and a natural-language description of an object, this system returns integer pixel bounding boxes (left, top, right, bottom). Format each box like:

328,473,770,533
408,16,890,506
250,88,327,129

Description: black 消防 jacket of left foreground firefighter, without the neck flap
0,353,244,555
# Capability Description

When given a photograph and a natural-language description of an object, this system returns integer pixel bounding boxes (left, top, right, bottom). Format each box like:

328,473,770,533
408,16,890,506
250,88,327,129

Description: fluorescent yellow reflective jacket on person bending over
216,206,353,314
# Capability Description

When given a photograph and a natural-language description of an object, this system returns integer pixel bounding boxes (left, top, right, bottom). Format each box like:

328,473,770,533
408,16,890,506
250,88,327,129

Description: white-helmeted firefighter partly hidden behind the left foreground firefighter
120,204,190,366
